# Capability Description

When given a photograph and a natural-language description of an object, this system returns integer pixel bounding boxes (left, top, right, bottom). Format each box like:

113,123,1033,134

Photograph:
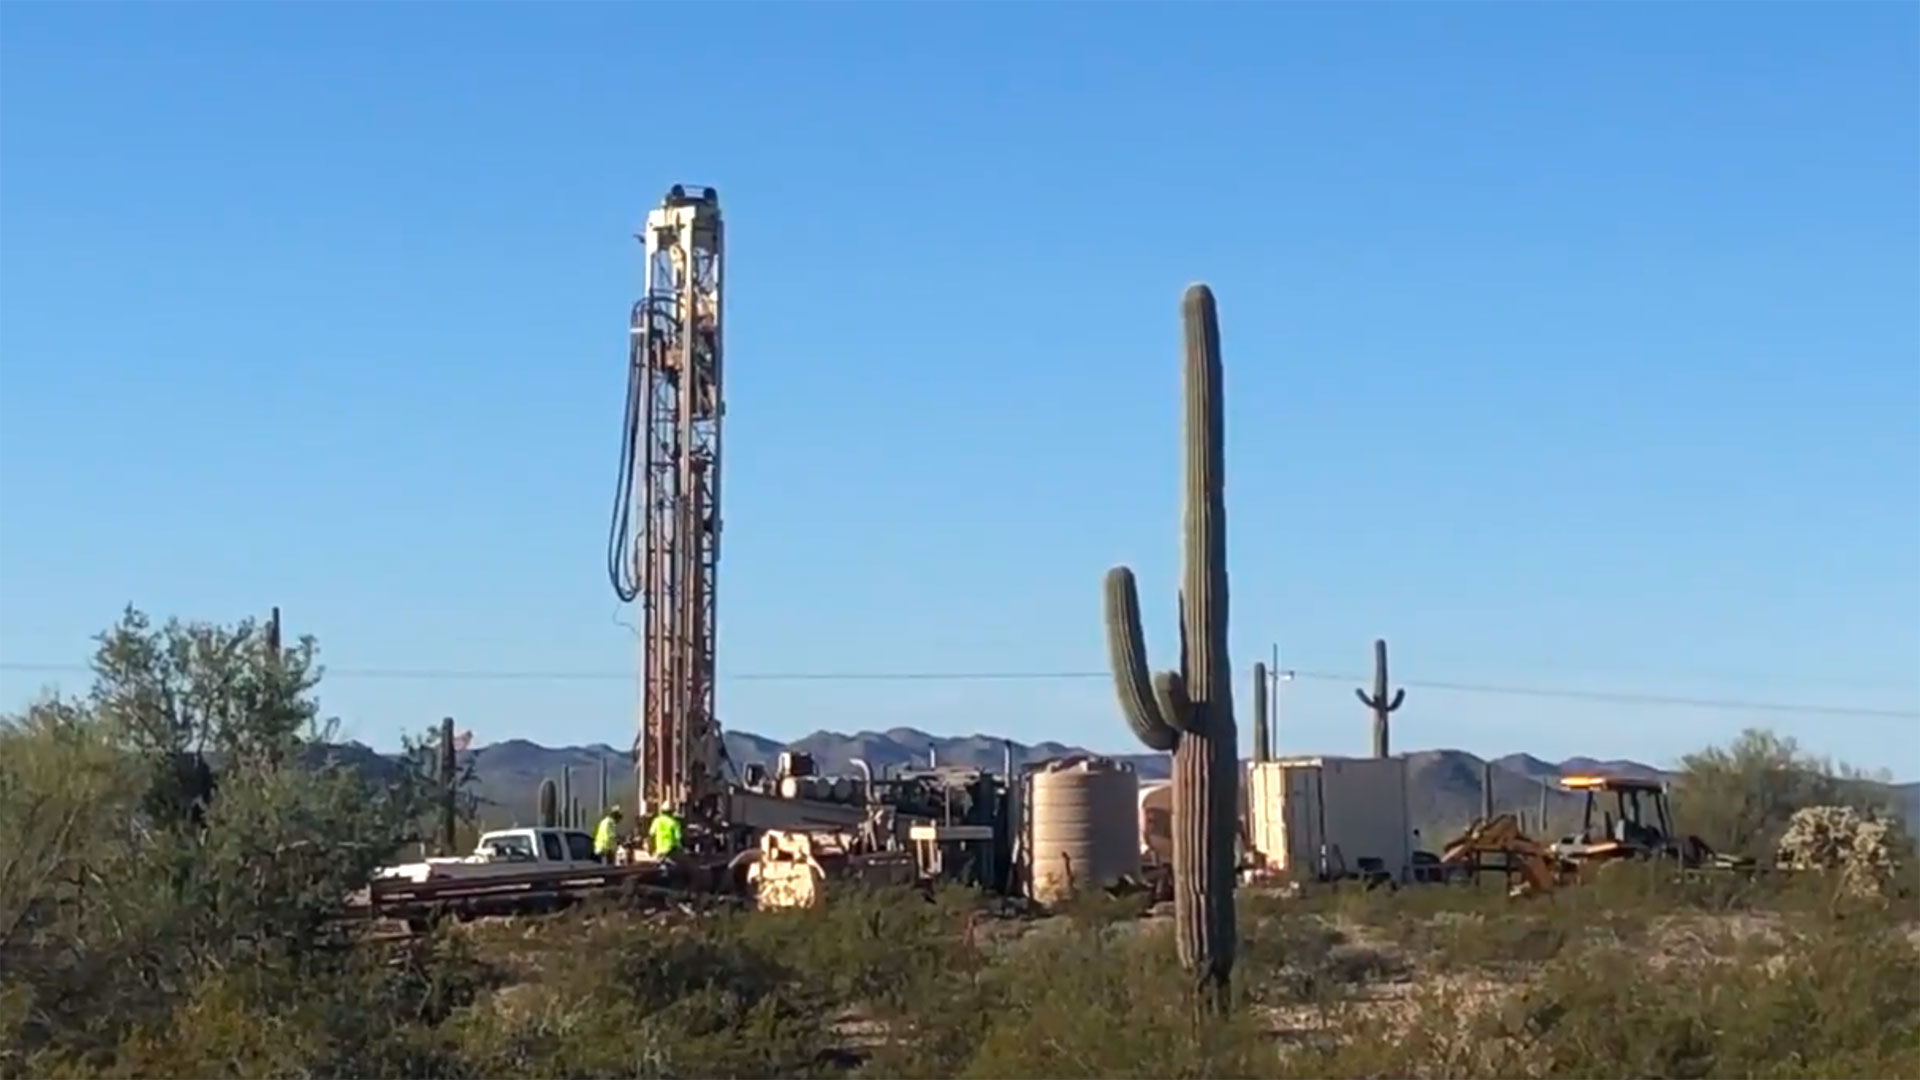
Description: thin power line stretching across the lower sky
0,661,1920,721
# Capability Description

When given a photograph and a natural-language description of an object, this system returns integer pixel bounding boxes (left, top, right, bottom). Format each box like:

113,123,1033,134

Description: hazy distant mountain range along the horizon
318,728,1920,834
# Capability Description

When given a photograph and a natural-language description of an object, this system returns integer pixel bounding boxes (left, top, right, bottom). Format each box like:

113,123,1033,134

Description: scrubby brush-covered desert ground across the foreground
18,864,1920,1076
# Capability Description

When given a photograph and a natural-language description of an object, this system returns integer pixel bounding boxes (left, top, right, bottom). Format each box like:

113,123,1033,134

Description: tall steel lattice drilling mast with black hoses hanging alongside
607,184,726,815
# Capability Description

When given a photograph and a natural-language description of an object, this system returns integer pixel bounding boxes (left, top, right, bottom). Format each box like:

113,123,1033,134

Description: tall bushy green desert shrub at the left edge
0,611,460,1070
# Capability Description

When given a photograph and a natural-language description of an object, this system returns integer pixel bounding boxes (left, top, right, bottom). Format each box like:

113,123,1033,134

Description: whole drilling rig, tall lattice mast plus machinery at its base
607,184,1008,891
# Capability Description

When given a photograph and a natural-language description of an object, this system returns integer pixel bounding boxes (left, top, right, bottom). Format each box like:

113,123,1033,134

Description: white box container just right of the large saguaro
1248,757,1413,882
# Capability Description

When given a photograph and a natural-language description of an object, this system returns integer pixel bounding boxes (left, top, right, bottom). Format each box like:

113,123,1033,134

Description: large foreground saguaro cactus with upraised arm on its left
1106,284,1240,1011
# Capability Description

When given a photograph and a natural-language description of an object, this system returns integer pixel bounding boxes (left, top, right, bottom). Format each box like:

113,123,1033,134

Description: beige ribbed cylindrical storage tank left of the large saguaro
1027,757,1140,903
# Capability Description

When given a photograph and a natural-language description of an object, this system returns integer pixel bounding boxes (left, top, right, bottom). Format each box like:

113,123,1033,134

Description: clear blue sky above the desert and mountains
0,4,1920,776
